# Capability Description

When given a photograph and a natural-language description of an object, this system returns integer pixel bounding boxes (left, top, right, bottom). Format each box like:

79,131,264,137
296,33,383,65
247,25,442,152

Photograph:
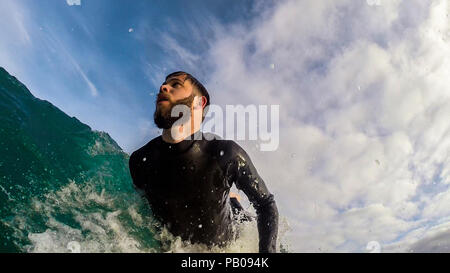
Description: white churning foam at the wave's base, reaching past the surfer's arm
21,182,288,253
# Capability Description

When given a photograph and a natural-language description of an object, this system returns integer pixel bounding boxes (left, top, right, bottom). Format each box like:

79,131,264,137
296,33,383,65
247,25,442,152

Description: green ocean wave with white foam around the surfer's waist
0,68,280,252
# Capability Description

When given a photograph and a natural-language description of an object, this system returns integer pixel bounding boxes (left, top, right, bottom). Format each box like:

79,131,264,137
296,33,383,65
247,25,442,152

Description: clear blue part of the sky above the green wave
0,0,266,152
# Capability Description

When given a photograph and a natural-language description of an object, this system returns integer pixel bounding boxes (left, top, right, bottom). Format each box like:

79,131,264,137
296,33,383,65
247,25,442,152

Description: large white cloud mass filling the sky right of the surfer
165,0,450,252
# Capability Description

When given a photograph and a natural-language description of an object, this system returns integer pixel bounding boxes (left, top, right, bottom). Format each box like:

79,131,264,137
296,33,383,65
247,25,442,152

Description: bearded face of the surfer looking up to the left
153,75,195,129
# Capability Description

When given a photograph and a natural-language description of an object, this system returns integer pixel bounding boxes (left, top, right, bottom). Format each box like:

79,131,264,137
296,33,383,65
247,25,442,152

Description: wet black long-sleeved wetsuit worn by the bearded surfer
130,131,278,252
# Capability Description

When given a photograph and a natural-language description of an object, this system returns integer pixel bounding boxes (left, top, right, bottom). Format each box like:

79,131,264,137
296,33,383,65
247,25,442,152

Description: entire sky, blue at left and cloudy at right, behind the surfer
0,0,450,252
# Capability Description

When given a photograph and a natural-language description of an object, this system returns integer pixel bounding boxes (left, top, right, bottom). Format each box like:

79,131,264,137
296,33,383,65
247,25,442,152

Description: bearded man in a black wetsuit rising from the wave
129,71,278,252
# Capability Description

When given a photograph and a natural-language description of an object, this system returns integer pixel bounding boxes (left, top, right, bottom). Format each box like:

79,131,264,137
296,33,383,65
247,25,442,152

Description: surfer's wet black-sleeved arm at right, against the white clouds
227,142,278,253
